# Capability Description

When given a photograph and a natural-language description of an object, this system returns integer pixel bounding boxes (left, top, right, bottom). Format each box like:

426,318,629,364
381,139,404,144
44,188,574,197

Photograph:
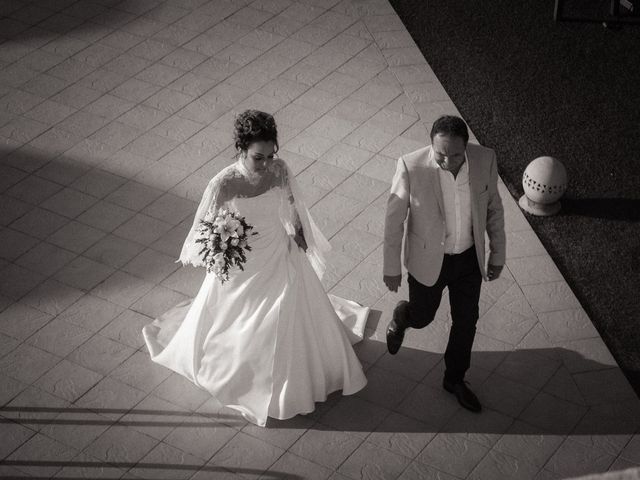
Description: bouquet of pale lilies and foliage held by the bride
196,208,257,283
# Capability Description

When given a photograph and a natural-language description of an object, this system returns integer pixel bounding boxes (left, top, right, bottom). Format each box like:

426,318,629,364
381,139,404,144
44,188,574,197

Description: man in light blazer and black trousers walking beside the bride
383,116,506,412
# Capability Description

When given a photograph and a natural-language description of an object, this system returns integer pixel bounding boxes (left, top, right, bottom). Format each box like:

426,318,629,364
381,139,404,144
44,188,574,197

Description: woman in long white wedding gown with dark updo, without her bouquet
143,110,369,426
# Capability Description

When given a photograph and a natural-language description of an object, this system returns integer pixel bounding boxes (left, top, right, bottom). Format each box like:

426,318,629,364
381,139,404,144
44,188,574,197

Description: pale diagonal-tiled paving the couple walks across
0,0,640,480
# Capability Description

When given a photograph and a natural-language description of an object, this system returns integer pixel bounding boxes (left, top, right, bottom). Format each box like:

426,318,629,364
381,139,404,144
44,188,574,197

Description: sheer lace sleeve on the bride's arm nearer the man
278,159,331,278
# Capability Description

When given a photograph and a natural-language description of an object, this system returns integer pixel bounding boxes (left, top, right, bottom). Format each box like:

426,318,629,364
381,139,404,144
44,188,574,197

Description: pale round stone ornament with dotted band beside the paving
518,157,567,217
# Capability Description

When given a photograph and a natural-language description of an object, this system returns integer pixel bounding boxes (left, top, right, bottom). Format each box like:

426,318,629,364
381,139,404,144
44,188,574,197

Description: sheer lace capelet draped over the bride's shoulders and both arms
178,158,331,278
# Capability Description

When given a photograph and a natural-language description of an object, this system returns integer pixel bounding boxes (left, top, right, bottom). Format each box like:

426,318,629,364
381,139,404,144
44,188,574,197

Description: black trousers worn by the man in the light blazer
407,246,482,382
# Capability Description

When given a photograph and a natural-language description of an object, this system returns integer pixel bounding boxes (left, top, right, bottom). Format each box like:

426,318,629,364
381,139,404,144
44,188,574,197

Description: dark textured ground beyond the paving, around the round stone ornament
391,0,640,395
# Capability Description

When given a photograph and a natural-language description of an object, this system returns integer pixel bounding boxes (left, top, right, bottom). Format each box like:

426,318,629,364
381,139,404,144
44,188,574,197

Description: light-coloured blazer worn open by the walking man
383,143,506,286
